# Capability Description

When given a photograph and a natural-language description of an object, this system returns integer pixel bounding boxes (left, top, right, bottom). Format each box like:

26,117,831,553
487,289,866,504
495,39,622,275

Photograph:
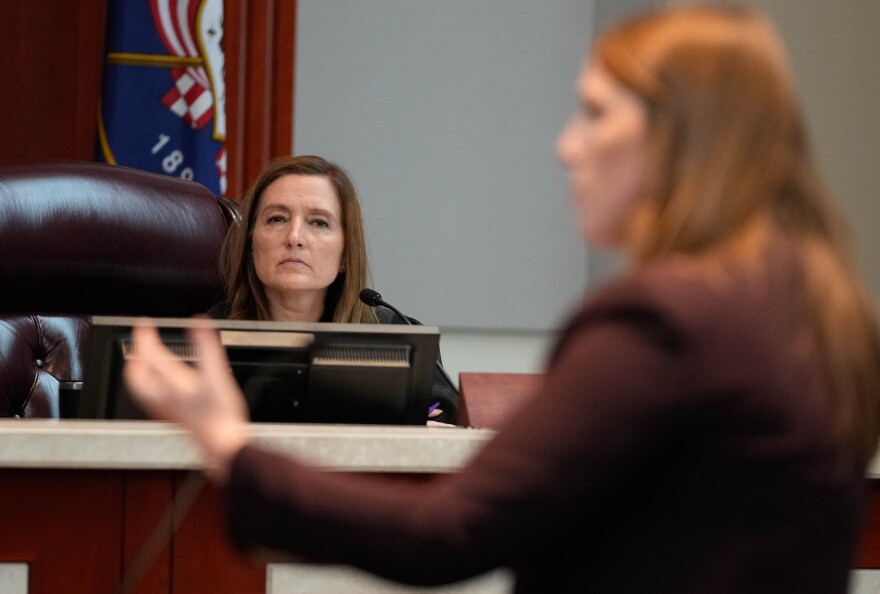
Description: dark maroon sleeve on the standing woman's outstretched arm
227,278,696,584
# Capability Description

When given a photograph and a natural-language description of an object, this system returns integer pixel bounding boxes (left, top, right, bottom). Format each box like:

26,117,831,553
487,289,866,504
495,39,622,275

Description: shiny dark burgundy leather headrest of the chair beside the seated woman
0,160,235,316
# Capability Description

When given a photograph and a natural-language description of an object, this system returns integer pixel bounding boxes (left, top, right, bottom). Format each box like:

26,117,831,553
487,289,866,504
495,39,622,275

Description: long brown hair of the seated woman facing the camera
221,155,376,323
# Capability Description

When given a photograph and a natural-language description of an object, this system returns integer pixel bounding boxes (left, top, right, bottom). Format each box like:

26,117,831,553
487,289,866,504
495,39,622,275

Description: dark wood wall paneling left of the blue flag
0,0,107,161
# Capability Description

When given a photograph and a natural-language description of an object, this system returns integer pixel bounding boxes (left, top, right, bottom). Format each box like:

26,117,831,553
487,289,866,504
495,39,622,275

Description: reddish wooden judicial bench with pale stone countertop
0,373,880,594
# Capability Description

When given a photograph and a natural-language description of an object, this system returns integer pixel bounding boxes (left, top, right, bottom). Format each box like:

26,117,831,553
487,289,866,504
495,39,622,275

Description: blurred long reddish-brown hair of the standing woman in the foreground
592,5,880,463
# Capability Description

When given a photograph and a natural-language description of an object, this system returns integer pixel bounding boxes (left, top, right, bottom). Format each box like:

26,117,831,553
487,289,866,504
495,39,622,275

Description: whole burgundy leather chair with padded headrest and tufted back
0,160,239,418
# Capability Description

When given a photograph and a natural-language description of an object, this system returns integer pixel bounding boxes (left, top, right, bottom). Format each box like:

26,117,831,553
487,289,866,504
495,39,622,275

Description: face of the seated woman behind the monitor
252,175,345,303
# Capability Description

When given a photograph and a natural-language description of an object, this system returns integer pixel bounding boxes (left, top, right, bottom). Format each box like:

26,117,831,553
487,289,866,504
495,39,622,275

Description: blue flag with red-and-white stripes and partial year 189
98,0,226,195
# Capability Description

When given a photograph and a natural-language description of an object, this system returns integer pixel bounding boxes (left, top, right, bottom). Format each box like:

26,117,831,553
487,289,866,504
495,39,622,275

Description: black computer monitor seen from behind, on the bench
78,316,440,425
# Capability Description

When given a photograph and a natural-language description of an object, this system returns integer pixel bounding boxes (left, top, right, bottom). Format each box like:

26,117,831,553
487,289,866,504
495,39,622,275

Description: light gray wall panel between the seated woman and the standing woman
294,0,593,330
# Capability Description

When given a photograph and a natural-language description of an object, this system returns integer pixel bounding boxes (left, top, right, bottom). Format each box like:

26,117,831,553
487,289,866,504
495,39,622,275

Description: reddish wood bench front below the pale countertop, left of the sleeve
0,469,266,594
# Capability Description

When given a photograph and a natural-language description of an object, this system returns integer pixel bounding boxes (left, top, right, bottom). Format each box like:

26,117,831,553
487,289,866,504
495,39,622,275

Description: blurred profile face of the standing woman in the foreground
557,64,648,248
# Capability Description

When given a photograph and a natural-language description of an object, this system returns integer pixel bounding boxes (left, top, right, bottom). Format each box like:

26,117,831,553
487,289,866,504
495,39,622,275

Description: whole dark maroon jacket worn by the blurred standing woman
227,265,865,594
